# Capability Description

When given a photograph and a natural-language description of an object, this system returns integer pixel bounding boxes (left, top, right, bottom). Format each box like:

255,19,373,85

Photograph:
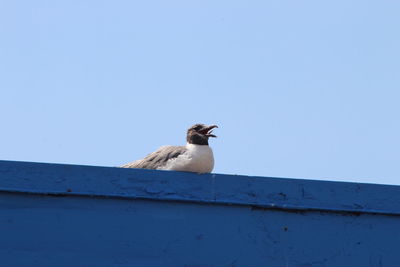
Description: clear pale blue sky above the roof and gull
0,0,400,184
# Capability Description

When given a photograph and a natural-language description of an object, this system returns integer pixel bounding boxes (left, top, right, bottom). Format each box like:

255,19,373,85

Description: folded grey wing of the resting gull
121,146,186,169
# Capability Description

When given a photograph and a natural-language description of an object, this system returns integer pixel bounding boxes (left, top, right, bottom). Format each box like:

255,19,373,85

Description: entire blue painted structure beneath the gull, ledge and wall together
0,161,400,266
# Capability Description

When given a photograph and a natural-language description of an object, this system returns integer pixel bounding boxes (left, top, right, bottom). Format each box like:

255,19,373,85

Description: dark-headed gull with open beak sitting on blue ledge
121,124,218,173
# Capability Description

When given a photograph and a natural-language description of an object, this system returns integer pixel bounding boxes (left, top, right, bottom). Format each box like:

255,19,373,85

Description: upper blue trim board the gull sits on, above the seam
0,160,400,216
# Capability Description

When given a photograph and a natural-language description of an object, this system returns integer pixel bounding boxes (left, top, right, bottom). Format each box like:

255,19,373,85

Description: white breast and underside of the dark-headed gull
160,144,214,173
